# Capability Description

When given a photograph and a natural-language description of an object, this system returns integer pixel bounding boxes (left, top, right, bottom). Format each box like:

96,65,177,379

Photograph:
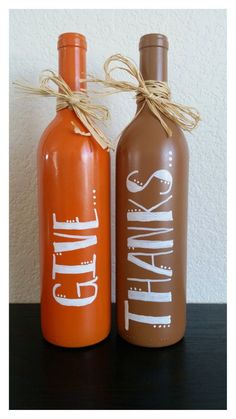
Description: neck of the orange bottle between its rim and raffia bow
58,45,86,92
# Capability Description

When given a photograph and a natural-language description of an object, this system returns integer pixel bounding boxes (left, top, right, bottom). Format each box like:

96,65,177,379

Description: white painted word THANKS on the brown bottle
124,169,174,330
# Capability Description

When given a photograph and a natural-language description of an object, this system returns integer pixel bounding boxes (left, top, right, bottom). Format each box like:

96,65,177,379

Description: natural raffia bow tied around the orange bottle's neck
14,70,113,149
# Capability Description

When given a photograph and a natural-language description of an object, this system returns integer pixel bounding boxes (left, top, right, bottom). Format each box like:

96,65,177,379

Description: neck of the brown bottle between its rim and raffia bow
139,46,168,82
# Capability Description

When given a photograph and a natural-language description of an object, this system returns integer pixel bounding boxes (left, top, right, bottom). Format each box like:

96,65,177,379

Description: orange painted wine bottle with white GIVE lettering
38,33,111,347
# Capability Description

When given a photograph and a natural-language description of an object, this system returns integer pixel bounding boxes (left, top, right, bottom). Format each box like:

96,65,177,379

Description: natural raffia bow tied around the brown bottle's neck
87,54,200,137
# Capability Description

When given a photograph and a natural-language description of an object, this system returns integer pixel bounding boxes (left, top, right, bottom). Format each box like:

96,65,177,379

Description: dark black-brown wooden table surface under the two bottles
10,304,226,409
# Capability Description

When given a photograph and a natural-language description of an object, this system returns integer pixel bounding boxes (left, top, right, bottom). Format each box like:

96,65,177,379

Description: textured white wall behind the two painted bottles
10,10,226,302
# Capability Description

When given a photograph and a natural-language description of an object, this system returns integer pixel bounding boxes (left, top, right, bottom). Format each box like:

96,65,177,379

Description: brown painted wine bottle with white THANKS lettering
116,34,189,347
